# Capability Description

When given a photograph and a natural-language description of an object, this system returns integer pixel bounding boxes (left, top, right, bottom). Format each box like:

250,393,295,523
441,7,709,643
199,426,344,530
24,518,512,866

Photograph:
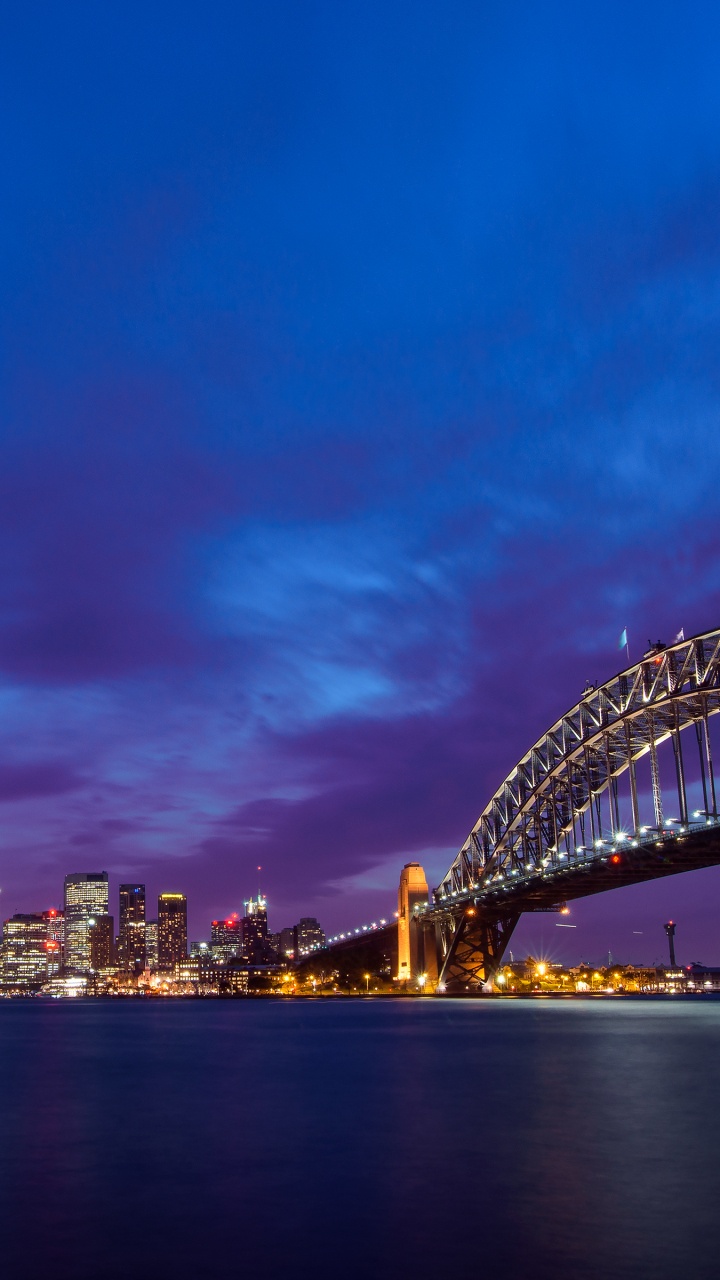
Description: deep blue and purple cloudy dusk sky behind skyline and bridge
0,0,720,963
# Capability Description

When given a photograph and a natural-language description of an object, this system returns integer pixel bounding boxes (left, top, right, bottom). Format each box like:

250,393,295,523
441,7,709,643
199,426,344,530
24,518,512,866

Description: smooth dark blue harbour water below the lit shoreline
0,998,720,1280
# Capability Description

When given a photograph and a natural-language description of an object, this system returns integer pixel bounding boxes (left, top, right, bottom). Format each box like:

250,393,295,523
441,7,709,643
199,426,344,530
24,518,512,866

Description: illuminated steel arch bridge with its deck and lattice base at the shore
415,630,720,991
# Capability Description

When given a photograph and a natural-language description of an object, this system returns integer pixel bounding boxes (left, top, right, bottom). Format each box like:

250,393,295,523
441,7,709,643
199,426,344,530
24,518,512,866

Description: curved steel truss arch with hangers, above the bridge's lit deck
434,630,720,902
